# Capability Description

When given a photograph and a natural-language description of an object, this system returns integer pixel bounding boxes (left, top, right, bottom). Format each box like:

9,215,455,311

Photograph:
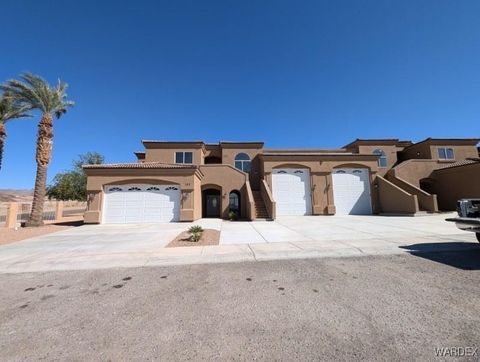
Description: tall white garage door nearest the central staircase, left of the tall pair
272,168,312,216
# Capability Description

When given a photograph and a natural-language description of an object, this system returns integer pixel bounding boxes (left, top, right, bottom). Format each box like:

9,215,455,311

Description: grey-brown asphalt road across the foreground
0,249,480,361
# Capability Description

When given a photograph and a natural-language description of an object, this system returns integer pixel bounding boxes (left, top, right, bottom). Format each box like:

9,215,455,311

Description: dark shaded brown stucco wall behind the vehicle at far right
432,163,480,211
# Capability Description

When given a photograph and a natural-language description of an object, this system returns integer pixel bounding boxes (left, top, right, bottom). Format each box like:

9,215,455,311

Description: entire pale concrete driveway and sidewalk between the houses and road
0,214,480,273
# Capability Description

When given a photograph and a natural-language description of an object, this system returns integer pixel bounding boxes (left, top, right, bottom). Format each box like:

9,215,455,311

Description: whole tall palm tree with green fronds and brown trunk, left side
1,73,74,226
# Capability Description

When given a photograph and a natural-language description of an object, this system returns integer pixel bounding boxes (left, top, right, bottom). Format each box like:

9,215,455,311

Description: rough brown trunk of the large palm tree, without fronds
26,113,53,226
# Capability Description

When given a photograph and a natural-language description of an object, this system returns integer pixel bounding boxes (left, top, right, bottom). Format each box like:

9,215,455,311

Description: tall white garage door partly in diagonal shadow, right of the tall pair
333,168,372,215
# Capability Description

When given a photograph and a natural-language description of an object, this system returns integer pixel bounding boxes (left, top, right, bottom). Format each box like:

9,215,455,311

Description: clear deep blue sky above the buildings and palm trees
0,0,480,188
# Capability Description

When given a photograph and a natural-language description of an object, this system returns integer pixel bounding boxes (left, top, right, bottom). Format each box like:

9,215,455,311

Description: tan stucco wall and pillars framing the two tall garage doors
263,155,378,215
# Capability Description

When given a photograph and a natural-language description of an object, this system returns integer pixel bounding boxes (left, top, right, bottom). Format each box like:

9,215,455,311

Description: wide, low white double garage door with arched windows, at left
103,185,180,224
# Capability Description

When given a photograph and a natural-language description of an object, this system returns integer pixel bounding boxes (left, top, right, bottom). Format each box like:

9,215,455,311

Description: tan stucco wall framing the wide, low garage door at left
85,169,202,223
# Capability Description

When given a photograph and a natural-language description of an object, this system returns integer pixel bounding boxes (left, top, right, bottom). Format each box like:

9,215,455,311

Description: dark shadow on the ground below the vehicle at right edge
400,242,480,270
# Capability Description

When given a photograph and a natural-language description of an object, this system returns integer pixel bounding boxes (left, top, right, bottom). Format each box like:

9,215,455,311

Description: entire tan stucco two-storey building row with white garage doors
84,138,480,223
